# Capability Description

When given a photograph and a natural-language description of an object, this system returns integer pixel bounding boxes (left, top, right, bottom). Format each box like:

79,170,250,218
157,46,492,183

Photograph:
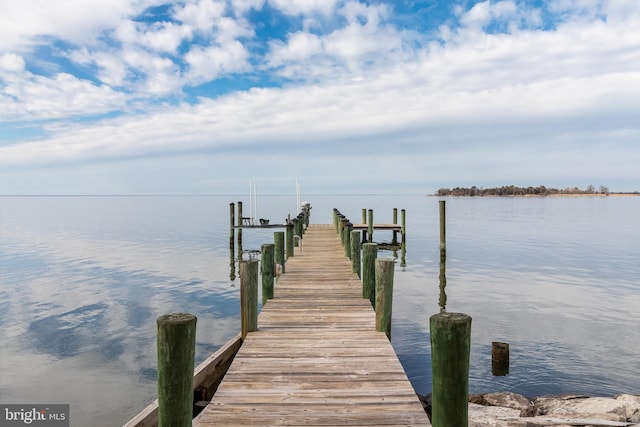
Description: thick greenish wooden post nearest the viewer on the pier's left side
157,313,197,427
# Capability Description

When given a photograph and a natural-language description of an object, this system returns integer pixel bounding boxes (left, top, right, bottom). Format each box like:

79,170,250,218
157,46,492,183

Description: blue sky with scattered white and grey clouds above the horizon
0,0,640,194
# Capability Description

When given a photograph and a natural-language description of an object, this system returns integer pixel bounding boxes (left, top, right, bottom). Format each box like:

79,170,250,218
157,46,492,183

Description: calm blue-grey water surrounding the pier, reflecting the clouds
0,196,640,427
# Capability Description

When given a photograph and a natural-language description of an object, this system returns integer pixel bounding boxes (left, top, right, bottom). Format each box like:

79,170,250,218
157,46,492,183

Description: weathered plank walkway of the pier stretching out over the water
193,225,430,426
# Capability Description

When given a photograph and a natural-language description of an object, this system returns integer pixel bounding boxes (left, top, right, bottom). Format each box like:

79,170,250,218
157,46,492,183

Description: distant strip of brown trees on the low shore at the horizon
435,185,609,196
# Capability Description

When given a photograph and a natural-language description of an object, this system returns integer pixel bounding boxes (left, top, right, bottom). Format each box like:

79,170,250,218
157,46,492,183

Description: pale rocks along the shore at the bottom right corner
420,392,640,427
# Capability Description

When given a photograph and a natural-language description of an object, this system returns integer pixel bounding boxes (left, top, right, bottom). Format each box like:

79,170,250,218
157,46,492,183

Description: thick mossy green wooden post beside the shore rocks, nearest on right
429,313,471,427
